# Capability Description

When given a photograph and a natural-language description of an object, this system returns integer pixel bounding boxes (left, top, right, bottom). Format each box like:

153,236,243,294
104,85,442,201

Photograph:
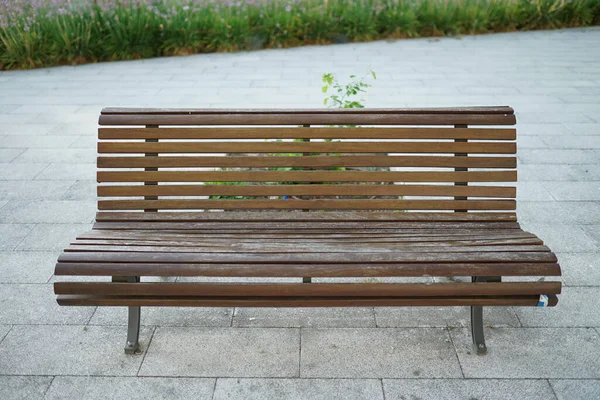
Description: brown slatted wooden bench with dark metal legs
54,107,561,353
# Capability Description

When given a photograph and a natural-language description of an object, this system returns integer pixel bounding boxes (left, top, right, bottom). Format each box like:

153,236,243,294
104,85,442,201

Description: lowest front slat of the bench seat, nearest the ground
57,295,558,307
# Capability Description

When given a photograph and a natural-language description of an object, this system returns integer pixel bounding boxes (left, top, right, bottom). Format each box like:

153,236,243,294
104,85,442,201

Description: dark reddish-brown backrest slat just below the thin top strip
98,113,516,125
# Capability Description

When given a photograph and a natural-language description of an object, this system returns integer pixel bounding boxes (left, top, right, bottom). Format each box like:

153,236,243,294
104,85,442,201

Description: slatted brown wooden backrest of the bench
98,107,517,211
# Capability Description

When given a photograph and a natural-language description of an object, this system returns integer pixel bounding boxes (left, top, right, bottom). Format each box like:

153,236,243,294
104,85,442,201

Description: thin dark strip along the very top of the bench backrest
101,106,514,115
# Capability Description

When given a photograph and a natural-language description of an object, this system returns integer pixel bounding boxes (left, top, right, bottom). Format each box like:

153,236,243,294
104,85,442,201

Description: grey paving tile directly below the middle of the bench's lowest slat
233,307,375,328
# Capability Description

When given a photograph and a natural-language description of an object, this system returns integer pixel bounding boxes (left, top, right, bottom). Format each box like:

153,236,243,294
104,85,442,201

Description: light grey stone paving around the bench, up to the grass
0,29,600,400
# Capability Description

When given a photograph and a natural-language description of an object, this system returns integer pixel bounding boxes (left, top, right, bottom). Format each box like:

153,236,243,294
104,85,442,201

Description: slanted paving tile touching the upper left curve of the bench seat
17,224,92,251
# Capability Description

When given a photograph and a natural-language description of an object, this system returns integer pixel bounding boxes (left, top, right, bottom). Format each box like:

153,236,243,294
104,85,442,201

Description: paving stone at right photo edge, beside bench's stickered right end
515,287,600,328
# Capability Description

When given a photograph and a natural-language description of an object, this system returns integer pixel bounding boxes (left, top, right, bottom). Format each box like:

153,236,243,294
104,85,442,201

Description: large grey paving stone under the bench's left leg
0,325,152,376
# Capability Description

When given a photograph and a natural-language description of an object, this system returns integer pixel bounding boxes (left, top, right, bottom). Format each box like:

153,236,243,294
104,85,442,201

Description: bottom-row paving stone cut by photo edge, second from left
44,376,215,400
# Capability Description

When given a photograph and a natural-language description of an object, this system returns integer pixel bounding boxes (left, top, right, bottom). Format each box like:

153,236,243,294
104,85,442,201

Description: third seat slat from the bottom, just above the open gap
54,261,561,278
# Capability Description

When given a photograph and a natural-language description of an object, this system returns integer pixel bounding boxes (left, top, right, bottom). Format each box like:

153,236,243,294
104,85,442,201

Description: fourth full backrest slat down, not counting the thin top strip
98,155,517,168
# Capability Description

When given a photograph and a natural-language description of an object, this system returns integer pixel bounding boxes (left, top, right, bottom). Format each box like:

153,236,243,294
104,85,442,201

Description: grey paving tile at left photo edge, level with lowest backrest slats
0,200,96,224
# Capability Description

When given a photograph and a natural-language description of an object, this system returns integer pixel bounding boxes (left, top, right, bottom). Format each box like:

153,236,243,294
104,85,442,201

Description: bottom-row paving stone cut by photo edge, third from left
213,378,384,400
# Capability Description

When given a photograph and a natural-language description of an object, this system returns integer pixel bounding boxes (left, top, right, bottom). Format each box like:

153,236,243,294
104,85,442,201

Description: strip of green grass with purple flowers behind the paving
0,0,600,70
